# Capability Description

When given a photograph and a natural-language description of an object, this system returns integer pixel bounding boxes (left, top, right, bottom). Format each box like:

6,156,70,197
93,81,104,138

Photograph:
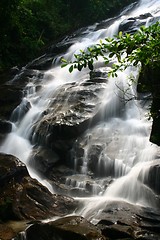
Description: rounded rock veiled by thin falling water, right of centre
73,122,130,178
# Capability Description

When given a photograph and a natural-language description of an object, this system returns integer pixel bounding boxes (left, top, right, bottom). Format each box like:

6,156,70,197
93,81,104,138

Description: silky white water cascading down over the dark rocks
0,0,160,219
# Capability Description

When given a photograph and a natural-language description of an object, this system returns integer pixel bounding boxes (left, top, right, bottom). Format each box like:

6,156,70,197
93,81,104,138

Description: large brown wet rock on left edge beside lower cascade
0,154,77,221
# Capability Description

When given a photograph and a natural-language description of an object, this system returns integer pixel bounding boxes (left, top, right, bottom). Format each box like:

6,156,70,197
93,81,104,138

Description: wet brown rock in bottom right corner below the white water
97,202,160,240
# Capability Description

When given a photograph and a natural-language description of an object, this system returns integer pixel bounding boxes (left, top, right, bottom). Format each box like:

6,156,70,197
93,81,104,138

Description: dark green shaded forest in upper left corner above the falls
0,0,135,70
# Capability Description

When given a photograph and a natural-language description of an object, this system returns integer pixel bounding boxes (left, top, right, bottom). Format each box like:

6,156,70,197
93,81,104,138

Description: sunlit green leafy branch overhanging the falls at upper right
62,22,160,76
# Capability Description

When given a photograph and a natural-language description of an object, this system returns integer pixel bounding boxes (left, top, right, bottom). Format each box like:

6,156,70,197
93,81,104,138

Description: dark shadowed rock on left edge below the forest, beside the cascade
0,68,43,120
